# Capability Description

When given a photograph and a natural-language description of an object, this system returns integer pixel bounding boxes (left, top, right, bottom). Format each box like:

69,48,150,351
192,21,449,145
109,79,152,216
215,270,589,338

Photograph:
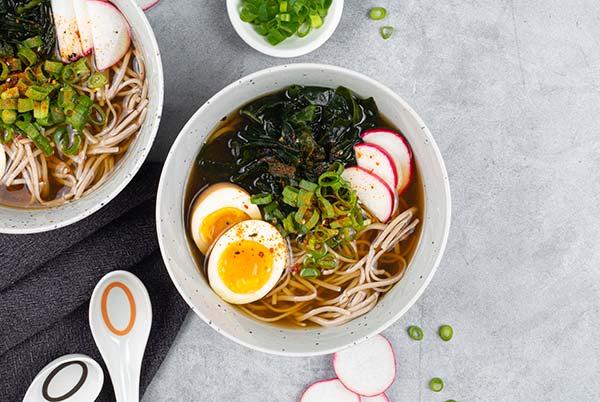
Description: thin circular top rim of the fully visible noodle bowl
156,63,452,357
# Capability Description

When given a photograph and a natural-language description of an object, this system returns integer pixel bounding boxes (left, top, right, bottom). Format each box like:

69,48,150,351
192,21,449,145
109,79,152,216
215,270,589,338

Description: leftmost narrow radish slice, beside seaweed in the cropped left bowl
51,0,83,63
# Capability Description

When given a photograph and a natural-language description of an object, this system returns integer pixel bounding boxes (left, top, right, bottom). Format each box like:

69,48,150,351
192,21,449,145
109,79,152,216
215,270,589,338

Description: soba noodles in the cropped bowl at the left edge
0,46,148,207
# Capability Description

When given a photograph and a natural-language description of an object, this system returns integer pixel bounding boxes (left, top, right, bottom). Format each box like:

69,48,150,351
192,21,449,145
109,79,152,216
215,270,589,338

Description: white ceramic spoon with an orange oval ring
90,271,152,402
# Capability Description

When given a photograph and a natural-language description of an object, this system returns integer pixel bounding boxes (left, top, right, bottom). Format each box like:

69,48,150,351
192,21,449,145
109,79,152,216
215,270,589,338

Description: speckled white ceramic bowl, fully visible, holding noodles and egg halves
156,64,450,356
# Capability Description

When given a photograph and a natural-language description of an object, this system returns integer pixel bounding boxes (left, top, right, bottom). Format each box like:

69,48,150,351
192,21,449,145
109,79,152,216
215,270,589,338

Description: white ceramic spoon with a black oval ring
23,355,104,402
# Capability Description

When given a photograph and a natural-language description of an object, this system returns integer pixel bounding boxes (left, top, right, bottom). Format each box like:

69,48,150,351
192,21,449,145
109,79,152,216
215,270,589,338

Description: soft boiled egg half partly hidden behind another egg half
190,183,261,255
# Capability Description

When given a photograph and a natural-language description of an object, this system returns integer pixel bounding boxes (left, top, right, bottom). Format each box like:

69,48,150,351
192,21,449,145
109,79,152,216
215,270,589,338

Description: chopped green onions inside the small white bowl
240,0,333,46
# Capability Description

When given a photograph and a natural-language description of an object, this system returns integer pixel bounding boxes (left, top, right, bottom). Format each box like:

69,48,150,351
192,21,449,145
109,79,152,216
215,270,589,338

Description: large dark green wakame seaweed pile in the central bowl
198,85,378,203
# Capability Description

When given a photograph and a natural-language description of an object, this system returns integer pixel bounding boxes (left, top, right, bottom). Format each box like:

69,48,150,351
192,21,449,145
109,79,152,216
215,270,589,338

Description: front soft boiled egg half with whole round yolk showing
207,220,288,304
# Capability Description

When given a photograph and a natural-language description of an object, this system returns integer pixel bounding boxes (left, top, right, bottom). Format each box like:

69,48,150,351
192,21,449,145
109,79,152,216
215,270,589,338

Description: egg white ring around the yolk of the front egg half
208,220,288,304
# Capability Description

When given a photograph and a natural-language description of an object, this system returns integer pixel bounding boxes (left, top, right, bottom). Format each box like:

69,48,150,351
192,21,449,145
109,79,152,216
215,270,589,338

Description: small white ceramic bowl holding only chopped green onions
227,0,344,58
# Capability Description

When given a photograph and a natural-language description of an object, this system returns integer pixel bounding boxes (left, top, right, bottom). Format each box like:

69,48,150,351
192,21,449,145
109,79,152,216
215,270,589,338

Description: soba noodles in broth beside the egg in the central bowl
240,207,419,326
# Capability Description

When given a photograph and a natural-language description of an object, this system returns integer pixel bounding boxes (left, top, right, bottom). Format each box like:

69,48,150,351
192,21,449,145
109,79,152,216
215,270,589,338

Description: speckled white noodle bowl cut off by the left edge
0,0,164,234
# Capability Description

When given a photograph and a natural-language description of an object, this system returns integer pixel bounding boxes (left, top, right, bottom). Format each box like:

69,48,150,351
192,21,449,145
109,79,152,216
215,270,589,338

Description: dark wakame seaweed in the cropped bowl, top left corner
0,0,56,58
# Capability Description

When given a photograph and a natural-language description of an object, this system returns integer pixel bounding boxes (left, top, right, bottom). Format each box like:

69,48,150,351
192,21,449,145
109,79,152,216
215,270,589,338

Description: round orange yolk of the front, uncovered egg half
219,240,273,294
